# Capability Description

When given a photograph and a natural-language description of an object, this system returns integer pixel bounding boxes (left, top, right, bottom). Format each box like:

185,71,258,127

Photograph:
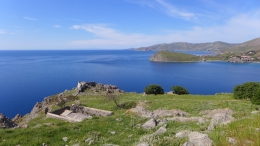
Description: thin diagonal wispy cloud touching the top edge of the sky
126,0,198,20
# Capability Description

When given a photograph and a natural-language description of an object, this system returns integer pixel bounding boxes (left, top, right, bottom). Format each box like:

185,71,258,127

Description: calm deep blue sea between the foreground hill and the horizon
0,50,260,118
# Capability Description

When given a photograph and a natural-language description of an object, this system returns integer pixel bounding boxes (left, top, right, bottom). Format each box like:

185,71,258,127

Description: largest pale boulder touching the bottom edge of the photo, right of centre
188,132,214,146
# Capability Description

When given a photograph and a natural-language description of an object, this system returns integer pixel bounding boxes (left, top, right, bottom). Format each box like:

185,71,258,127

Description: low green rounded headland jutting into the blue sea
149,51,201,62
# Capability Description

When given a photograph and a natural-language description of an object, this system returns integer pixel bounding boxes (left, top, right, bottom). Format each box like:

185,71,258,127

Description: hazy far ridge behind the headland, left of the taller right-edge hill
132,41,237,52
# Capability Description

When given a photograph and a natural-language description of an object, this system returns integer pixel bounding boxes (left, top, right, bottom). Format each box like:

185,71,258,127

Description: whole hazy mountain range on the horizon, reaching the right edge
131,38,260,52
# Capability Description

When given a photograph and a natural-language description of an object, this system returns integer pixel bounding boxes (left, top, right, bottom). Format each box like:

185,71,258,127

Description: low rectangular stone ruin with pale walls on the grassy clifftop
46,105,113,122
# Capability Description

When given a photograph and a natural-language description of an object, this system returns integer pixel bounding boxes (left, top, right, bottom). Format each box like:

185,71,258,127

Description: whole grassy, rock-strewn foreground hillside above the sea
0,82,260,146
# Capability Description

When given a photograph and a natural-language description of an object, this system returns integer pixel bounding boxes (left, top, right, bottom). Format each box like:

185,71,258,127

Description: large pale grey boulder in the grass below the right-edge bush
208,113,234,130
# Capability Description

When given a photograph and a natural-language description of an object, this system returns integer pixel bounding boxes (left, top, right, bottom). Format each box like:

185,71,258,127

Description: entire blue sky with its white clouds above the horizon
0,0,260,50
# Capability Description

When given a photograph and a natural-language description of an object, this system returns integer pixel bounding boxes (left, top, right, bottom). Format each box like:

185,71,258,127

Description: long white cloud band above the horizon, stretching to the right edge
71,11,260,48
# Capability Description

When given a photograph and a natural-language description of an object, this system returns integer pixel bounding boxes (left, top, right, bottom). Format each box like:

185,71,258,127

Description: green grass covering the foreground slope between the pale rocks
0,93,260,146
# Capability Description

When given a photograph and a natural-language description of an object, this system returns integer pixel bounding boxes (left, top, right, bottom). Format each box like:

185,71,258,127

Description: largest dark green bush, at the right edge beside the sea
233,82,260,99
